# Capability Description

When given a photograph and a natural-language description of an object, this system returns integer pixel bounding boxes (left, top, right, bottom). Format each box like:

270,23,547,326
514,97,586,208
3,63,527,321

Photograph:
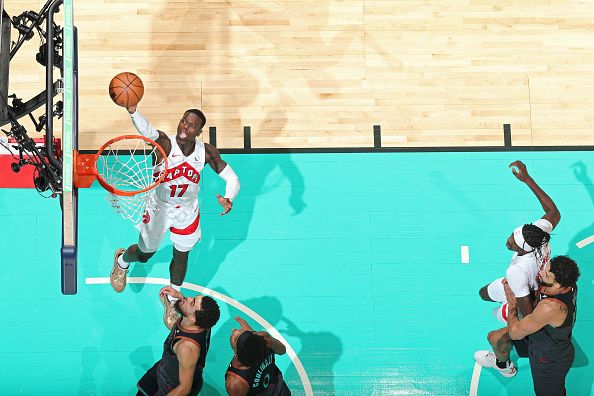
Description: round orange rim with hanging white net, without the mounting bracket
97,137,166,224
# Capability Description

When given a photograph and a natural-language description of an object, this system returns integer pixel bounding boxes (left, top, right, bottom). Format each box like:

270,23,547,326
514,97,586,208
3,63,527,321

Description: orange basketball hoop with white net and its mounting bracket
73,135,167,224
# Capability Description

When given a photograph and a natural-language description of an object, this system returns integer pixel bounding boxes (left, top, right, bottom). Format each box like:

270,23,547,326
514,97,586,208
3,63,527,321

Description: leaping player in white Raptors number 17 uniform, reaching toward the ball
110,106,239,328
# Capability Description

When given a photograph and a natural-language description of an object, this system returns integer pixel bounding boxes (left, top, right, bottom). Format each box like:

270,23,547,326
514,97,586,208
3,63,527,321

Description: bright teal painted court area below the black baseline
0,151,594,396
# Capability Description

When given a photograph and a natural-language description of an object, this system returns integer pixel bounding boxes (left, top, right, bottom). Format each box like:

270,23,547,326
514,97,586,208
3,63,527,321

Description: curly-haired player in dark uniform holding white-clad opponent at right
474,256,580,396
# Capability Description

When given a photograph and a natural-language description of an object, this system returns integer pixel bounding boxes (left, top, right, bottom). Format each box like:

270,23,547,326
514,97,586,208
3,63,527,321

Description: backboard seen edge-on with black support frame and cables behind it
0,0,78,294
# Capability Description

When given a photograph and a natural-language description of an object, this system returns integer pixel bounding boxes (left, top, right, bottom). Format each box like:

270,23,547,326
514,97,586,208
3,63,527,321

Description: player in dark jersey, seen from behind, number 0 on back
225,316,291,396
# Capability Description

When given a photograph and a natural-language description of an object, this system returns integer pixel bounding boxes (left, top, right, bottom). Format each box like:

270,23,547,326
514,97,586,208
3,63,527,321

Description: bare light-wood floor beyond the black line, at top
5,0,594,150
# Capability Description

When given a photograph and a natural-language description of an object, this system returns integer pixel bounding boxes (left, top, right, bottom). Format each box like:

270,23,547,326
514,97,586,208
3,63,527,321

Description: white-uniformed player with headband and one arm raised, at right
479,161,561,323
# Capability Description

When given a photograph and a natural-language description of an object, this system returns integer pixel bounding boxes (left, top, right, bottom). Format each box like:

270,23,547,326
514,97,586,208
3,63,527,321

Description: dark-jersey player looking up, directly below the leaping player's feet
136,286,220,396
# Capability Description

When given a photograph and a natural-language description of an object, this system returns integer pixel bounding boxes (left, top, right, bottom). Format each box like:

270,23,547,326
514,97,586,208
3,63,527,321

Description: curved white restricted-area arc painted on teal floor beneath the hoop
85,277,313,396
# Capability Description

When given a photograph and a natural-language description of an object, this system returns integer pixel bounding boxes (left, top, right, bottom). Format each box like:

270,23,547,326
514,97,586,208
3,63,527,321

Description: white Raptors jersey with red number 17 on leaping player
155,136,205,211
